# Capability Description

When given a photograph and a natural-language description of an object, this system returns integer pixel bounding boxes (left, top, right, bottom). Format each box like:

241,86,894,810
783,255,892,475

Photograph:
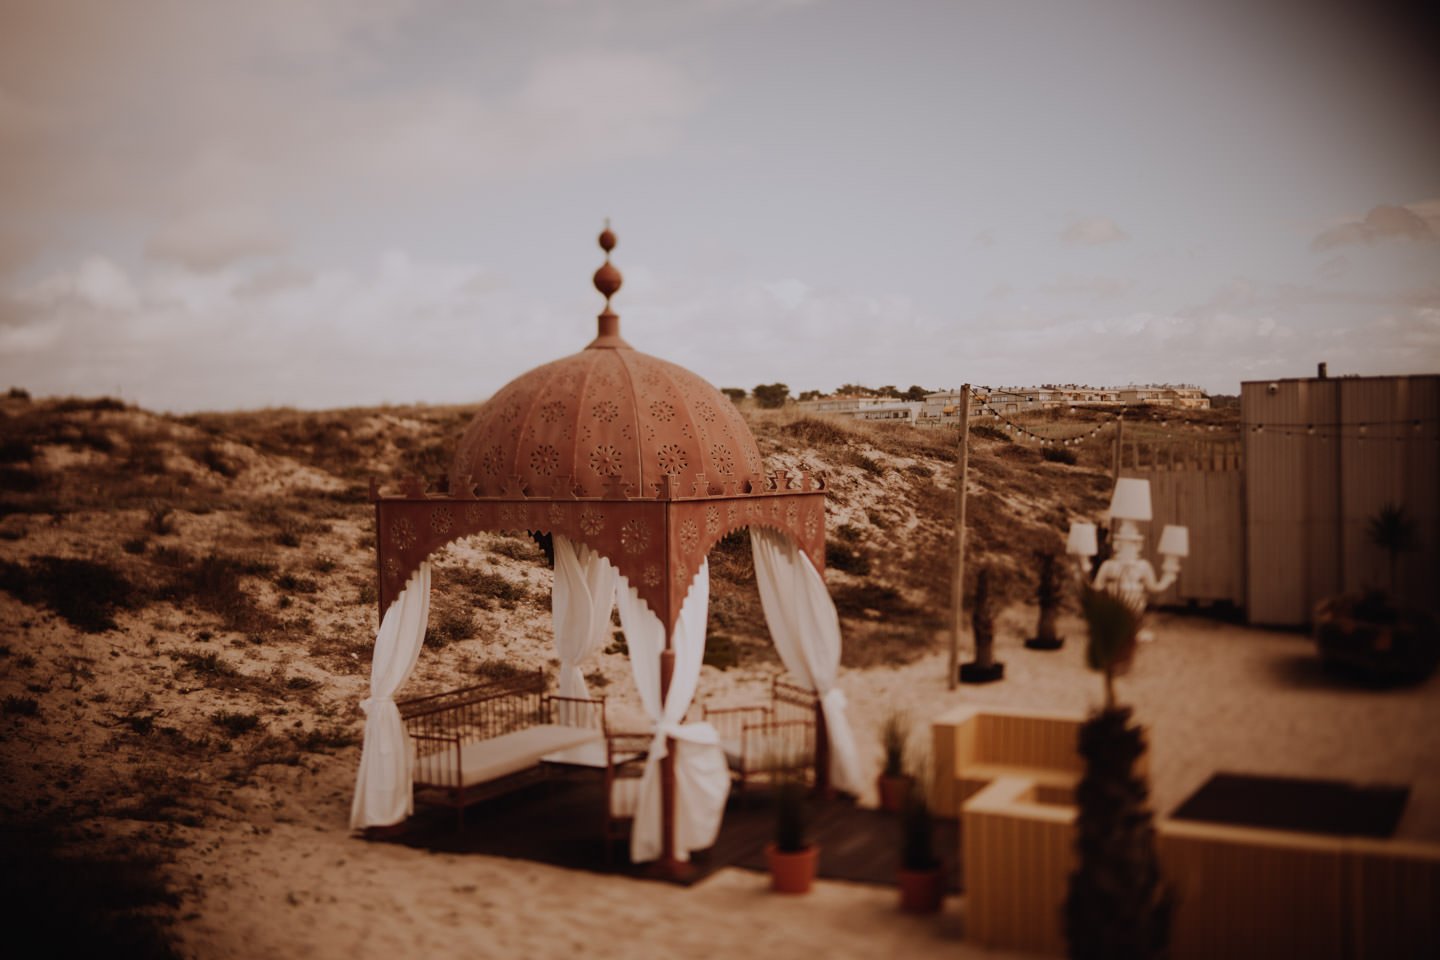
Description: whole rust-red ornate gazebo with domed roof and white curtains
351,227,858,864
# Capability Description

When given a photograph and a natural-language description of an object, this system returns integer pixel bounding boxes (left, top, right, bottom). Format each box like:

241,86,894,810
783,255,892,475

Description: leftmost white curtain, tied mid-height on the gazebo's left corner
350,561,431,830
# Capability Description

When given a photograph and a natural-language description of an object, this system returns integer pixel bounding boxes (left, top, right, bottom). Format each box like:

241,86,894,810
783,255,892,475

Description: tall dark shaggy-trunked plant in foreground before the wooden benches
1064,587,1174,957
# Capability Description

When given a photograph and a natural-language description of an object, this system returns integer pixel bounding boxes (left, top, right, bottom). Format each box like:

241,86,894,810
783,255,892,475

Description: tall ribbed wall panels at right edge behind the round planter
1240,376,1440,626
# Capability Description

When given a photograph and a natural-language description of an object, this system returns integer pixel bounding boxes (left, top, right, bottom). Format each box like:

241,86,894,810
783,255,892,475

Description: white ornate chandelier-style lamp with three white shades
1066,476,1189,627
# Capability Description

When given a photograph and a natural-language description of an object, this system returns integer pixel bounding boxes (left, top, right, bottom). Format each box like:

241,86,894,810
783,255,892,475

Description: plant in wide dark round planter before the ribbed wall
1315,504,1440,684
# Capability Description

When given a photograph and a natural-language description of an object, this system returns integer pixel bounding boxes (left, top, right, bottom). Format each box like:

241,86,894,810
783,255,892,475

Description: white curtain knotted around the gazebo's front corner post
615,561,730,864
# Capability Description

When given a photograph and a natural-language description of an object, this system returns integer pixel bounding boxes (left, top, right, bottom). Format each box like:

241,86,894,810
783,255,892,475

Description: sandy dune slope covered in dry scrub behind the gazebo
0,396,1238,956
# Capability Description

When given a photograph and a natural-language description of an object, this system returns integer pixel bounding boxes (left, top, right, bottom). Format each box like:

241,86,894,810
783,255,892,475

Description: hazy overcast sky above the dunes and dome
0,0,1440,410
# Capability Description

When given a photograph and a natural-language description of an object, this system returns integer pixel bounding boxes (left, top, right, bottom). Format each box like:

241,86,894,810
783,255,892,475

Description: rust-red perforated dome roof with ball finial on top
449,229,763,499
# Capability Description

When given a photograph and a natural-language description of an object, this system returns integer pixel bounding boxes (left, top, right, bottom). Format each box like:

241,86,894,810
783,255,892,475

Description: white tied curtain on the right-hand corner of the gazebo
750,527,861,794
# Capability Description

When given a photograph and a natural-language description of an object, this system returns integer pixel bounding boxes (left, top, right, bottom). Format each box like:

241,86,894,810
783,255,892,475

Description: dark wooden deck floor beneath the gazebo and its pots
369,779,959,892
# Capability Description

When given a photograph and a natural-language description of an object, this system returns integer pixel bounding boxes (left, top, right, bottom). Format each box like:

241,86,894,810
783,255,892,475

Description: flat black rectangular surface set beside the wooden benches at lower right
1171,773,1410,838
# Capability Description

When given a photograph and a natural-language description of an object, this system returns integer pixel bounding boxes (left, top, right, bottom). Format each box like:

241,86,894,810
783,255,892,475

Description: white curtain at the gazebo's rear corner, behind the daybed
550,534,619,705
